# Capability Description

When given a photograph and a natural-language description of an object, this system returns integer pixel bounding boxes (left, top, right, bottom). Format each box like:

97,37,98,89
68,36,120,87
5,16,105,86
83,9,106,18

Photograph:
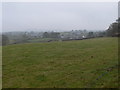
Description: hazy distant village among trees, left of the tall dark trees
0,30,106,44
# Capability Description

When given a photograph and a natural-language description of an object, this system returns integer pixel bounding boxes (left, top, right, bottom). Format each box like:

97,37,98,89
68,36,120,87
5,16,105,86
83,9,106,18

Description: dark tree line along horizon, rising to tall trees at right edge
1,18,120,46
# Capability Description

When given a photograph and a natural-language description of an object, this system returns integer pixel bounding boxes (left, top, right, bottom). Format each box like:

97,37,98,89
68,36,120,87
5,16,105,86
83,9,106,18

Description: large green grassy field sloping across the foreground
3,38,118,88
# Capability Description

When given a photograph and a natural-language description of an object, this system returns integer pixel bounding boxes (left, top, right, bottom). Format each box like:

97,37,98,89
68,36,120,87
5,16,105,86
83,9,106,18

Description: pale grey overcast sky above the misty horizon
0,2,118,32
